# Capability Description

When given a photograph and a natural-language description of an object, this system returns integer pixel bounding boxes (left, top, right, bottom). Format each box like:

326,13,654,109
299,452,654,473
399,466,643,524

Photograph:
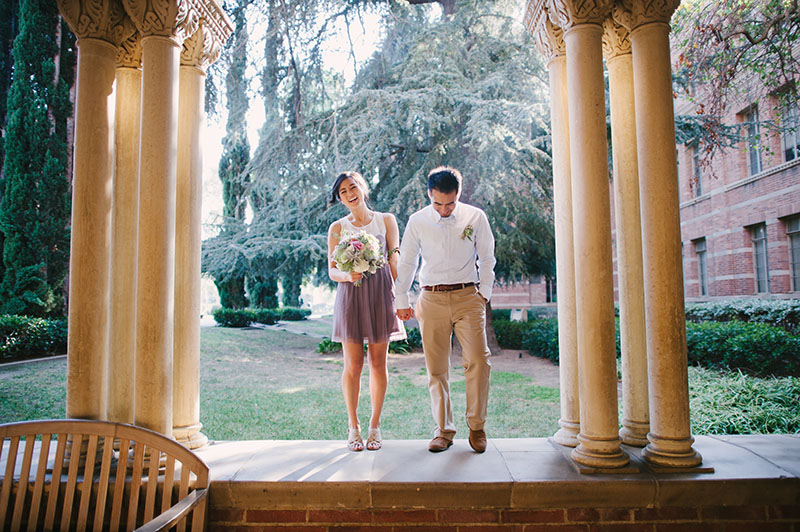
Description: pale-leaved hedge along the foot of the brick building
686,299,800,333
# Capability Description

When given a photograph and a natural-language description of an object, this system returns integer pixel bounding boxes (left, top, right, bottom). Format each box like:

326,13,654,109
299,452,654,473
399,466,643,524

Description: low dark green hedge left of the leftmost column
0,315,67,358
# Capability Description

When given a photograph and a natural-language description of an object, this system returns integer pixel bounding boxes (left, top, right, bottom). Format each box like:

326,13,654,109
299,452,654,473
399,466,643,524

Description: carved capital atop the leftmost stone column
58,0,136,46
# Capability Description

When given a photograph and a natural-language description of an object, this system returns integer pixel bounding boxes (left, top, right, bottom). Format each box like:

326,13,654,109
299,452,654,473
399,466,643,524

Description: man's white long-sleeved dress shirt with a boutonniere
394,202,497,309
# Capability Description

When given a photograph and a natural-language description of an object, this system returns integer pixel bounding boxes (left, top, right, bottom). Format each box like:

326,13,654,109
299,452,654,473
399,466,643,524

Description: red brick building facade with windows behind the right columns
676,91,800,301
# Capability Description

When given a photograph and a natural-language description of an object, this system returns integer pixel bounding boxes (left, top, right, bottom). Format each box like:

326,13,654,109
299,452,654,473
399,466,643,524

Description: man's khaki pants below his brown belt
415,286,492,440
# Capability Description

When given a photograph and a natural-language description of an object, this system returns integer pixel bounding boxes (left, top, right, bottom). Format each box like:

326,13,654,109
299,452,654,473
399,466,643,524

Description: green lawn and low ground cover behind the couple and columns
0,324,800,440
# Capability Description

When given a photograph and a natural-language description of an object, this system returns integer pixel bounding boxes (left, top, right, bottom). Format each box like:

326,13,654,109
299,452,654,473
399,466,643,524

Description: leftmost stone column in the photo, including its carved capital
58,0,125,419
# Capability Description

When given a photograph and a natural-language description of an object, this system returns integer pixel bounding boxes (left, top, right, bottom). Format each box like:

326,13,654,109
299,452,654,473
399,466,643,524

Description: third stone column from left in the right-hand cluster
603,17,650,447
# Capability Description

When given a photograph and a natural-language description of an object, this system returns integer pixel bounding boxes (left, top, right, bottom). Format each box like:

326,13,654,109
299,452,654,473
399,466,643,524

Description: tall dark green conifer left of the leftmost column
0,0,74,316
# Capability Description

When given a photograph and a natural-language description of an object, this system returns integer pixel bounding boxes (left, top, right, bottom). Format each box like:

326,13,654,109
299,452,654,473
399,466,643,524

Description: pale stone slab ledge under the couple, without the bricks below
198,435,800,511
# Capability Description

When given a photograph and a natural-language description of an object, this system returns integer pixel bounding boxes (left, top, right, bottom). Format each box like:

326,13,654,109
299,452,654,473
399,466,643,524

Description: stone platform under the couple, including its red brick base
198,435,800,532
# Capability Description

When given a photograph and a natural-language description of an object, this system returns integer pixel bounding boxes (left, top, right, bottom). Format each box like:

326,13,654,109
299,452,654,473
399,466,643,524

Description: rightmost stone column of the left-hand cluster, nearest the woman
172,24,220,449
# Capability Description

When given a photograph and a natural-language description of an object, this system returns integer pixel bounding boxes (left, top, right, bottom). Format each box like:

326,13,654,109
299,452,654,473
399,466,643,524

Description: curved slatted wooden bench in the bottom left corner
0,419,208,532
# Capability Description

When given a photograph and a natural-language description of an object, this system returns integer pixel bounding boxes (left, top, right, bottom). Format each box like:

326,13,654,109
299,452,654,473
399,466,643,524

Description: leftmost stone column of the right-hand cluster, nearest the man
528,5,580,447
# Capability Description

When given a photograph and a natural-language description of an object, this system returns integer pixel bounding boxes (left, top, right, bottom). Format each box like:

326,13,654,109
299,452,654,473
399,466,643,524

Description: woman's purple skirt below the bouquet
331,264,406,344
